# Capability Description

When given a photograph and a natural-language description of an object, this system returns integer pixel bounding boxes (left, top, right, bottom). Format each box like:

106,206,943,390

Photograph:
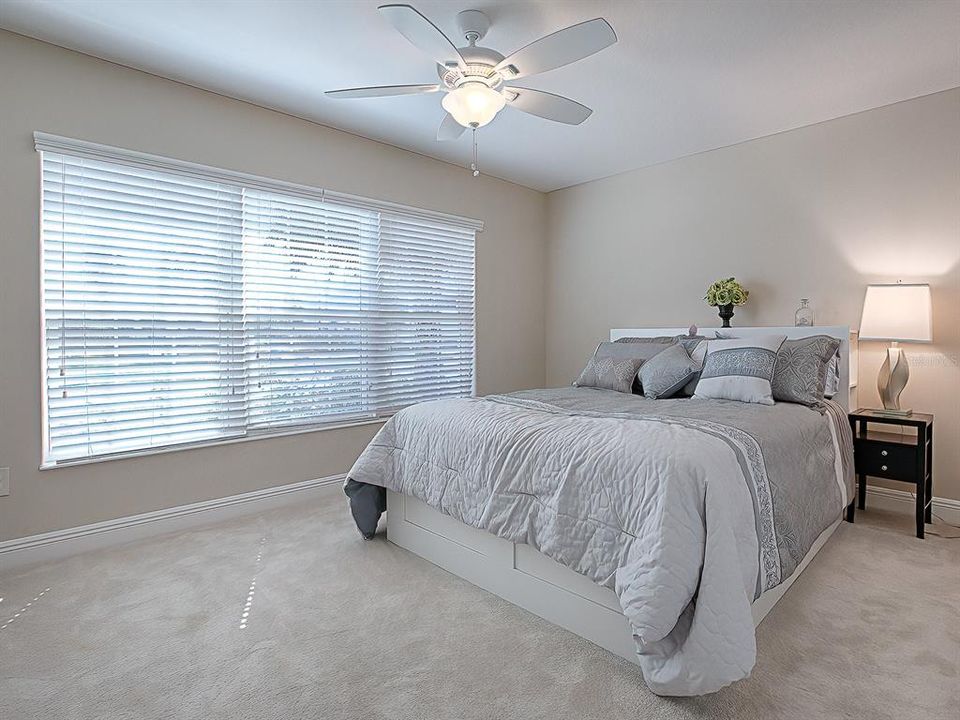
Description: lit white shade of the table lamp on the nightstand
860,285,933,342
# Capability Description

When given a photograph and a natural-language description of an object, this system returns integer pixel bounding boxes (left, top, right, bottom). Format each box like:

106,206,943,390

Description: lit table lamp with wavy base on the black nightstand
860,283,933,416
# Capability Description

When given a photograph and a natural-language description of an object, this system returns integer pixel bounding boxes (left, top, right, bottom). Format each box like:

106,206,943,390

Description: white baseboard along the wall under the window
0,475,344,572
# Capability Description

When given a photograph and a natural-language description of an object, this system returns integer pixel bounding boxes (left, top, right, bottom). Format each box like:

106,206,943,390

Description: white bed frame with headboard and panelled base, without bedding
387,326,850,663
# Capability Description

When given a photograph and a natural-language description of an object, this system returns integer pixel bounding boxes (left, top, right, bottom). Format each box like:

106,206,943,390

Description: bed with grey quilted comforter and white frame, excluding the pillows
349,327,854,695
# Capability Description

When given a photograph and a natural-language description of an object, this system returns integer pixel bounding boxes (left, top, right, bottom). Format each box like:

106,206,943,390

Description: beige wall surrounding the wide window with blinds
0,31,546,540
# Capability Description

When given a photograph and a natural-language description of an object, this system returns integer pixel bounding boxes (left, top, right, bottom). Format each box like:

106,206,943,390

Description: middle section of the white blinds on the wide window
243,191,377,428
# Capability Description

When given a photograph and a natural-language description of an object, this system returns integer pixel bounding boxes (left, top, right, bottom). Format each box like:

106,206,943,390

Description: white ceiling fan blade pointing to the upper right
497,18,617,80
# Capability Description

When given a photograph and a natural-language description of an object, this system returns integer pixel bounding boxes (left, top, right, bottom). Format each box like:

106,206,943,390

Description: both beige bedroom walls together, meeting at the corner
0,31,960,540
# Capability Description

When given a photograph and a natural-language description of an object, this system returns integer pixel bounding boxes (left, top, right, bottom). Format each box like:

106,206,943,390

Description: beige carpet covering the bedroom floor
0,488,960,720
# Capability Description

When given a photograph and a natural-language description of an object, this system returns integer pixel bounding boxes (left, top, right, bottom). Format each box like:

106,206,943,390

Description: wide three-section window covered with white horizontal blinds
37,133,480,464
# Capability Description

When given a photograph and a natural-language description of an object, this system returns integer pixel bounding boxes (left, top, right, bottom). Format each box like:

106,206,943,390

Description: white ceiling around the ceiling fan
0,0,960,191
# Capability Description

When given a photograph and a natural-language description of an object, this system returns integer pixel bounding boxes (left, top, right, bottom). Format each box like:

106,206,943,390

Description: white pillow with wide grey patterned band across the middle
694,335,786,405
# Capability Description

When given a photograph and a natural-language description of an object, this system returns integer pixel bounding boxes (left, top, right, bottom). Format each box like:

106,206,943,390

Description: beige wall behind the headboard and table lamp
547,90,960,499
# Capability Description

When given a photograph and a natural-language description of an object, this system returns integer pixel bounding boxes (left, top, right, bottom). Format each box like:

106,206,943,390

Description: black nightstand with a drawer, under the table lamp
847,408,933,538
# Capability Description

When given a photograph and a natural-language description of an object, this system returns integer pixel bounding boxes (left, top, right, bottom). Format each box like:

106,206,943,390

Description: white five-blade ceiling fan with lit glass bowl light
326,5,617,143
